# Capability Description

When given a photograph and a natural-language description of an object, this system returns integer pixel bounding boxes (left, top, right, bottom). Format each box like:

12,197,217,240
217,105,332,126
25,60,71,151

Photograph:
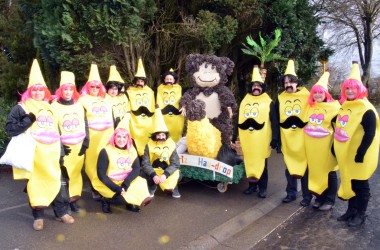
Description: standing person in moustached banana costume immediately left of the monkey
157,69,185,143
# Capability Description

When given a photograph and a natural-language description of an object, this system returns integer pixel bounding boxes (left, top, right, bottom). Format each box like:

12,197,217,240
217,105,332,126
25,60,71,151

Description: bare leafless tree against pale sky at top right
312,0,380,91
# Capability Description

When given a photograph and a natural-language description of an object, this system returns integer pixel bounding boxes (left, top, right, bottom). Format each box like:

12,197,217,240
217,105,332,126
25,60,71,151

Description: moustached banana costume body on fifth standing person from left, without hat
127,86,155,156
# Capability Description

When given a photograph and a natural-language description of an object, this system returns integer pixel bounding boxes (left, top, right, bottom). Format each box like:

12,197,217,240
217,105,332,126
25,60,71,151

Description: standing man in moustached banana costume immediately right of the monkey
233,65,279,198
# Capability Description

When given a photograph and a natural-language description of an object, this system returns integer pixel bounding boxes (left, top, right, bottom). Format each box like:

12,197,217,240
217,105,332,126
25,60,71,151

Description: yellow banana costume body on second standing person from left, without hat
52,102,86,197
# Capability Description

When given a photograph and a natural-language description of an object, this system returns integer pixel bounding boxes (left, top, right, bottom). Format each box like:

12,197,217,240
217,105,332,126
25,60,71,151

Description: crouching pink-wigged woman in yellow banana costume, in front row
97,128,152,213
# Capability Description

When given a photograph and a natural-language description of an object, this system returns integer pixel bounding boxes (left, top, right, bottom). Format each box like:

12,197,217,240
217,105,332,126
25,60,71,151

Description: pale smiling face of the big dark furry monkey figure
193,62,220,87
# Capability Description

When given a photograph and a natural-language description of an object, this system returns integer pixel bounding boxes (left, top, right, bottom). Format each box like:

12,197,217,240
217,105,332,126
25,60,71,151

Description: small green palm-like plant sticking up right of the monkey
241,29,286,69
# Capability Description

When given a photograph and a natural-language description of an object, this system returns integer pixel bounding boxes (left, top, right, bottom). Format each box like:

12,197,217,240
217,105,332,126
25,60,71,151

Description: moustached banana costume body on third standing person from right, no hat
278,87,310,176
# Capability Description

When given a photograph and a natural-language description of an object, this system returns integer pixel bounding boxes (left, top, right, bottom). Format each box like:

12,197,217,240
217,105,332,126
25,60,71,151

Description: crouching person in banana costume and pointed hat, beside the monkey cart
142,108,182,198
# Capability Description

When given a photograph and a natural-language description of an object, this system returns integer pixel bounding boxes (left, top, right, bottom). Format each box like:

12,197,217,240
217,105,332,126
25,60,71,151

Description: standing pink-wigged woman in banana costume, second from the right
304,71,340,211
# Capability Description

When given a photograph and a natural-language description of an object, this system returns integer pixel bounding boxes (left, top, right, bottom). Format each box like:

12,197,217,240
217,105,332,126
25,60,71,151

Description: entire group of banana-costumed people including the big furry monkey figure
2,54,380,230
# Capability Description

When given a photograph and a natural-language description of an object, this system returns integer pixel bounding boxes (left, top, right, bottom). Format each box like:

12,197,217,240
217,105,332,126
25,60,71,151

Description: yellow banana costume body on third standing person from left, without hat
78,95,114,182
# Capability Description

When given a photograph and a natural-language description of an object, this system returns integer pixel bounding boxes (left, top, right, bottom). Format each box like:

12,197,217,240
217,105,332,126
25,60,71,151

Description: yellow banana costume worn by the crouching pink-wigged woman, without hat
93,145,150,206
